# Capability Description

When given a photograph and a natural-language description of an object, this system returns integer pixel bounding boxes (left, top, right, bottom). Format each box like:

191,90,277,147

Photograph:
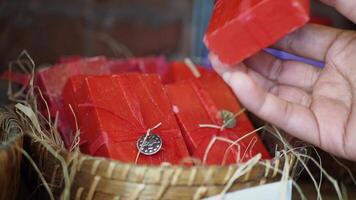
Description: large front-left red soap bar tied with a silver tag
63,74,189,165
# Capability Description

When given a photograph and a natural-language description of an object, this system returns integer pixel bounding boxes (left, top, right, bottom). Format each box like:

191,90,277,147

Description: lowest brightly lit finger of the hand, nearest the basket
224,65,319,144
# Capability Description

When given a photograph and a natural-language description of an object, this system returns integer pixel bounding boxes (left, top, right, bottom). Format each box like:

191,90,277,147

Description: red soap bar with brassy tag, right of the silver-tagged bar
166,80,270,165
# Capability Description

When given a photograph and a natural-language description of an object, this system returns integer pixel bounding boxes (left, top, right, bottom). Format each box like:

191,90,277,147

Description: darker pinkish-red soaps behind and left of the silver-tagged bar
36,57,168,146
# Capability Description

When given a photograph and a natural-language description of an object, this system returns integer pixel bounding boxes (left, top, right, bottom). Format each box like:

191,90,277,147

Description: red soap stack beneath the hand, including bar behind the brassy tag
166,62,270,164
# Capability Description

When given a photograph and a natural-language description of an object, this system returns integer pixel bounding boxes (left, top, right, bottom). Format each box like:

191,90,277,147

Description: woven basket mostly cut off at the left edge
0,107,22,200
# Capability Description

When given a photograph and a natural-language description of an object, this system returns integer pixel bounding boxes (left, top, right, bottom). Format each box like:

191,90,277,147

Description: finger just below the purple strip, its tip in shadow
245,52,320,92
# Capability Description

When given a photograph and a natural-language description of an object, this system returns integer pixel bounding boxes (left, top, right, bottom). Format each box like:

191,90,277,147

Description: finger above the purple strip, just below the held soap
274,23,344,61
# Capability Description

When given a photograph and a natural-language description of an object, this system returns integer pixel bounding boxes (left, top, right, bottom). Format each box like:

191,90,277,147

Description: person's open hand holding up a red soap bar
210,0,356,161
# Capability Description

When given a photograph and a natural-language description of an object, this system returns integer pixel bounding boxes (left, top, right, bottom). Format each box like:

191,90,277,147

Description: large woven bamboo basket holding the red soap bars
15,103,298,200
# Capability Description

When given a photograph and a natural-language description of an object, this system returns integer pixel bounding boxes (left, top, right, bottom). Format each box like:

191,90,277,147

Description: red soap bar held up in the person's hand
204,0,310,64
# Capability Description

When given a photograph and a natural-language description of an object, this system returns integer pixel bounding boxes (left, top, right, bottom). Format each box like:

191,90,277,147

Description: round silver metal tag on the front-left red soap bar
137,134,162,156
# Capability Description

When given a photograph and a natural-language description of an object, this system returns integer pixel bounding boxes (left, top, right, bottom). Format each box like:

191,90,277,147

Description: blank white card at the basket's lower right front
205,181,292,200
